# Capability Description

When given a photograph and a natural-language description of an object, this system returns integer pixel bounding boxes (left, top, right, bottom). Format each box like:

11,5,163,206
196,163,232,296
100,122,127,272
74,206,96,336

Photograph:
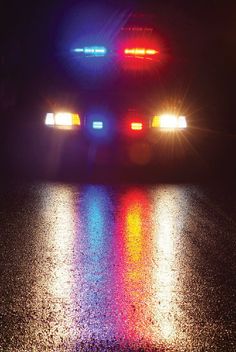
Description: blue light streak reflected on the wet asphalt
79,186,114,340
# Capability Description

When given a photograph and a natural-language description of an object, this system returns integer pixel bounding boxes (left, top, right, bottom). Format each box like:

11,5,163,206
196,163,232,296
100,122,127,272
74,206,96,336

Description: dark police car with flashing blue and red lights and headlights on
44,14,188,175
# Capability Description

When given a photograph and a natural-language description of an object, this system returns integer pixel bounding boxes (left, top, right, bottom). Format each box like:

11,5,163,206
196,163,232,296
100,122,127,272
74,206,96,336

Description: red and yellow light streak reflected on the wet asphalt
114,189,152,344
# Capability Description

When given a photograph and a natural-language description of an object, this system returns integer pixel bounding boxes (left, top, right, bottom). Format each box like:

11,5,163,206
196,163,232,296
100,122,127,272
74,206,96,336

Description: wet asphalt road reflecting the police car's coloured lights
0,183,236,352
